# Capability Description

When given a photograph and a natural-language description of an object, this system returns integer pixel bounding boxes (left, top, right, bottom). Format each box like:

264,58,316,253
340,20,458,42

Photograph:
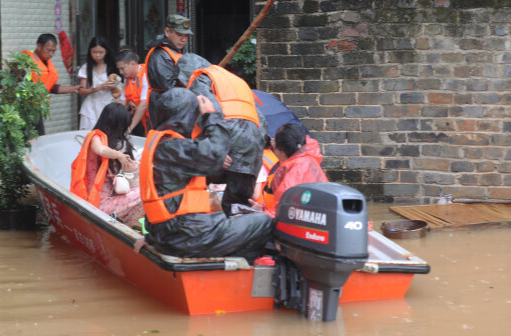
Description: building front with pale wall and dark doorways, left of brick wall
0,0,253,133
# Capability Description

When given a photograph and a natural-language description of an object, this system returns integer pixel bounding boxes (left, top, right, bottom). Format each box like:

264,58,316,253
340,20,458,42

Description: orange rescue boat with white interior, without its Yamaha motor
23,131,429,315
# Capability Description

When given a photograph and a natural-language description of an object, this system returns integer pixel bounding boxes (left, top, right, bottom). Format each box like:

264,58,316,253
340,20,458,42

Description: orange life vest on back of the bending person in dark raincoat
187,65,259,127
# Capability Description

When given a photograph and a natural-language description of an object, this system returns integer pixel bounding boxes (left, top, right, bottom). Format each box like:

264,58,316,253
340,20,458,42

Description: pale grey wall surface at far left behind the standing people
0,0,77,133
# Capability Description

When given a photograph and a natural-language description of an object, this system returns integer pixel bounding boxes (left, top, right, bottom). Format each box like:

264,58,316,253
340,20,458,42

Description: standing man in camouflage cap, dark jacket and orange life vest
145,15,193,128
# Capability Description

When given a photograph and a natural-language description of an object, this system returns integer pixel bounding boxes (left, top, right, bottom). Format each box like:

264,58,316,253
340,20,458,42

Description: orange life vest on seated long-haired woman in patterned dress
70,130,108,207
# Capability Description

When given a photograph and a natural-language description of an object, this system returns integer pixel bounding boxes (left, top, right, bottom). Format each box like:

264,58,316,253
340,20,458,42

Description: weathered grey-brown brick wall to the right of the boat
256,0,511,204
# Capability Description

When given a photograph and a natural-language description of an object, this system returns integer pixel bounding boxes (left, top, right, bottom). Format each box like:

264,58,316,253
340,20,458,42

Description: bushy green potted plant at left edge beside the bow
0,52,50,229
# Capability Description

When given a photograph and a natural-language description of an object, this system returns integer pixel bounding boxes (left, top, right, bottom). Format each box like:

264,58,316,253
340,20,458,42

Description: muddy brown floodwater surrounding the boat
0,204,511,336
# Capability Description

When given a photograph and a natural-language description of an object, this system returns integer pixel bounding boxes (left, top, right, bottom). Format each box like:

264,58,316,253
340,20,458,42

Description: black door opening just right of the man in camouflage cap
195,0,250,64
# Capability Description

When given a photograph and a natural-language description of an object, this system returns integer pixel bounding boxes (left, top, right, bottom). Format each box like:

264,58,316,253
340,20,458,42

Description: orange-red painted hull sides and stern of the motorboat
37,187,420,315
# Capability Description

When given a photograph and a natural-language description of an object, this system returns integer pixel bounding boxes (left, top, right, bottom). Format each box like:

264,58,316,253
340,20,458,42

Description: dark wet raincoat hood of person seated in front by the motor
156,88,199,138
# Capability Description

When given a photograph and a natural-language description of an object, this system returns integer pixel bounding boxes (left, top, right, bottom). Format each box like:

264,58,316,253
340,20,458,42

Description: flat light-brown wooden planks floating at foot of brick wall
390,203,511,231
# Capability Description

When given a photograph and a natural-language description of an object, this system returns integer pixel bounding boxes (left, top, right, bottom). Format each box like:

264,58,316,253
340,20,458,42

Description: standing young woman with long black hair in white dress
78,36,122,130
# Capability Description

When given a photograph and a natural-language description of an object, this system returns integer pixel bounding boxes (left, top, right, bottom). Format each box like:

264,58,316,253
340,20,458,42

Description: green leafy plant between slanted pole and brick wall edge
227,36,256,88
